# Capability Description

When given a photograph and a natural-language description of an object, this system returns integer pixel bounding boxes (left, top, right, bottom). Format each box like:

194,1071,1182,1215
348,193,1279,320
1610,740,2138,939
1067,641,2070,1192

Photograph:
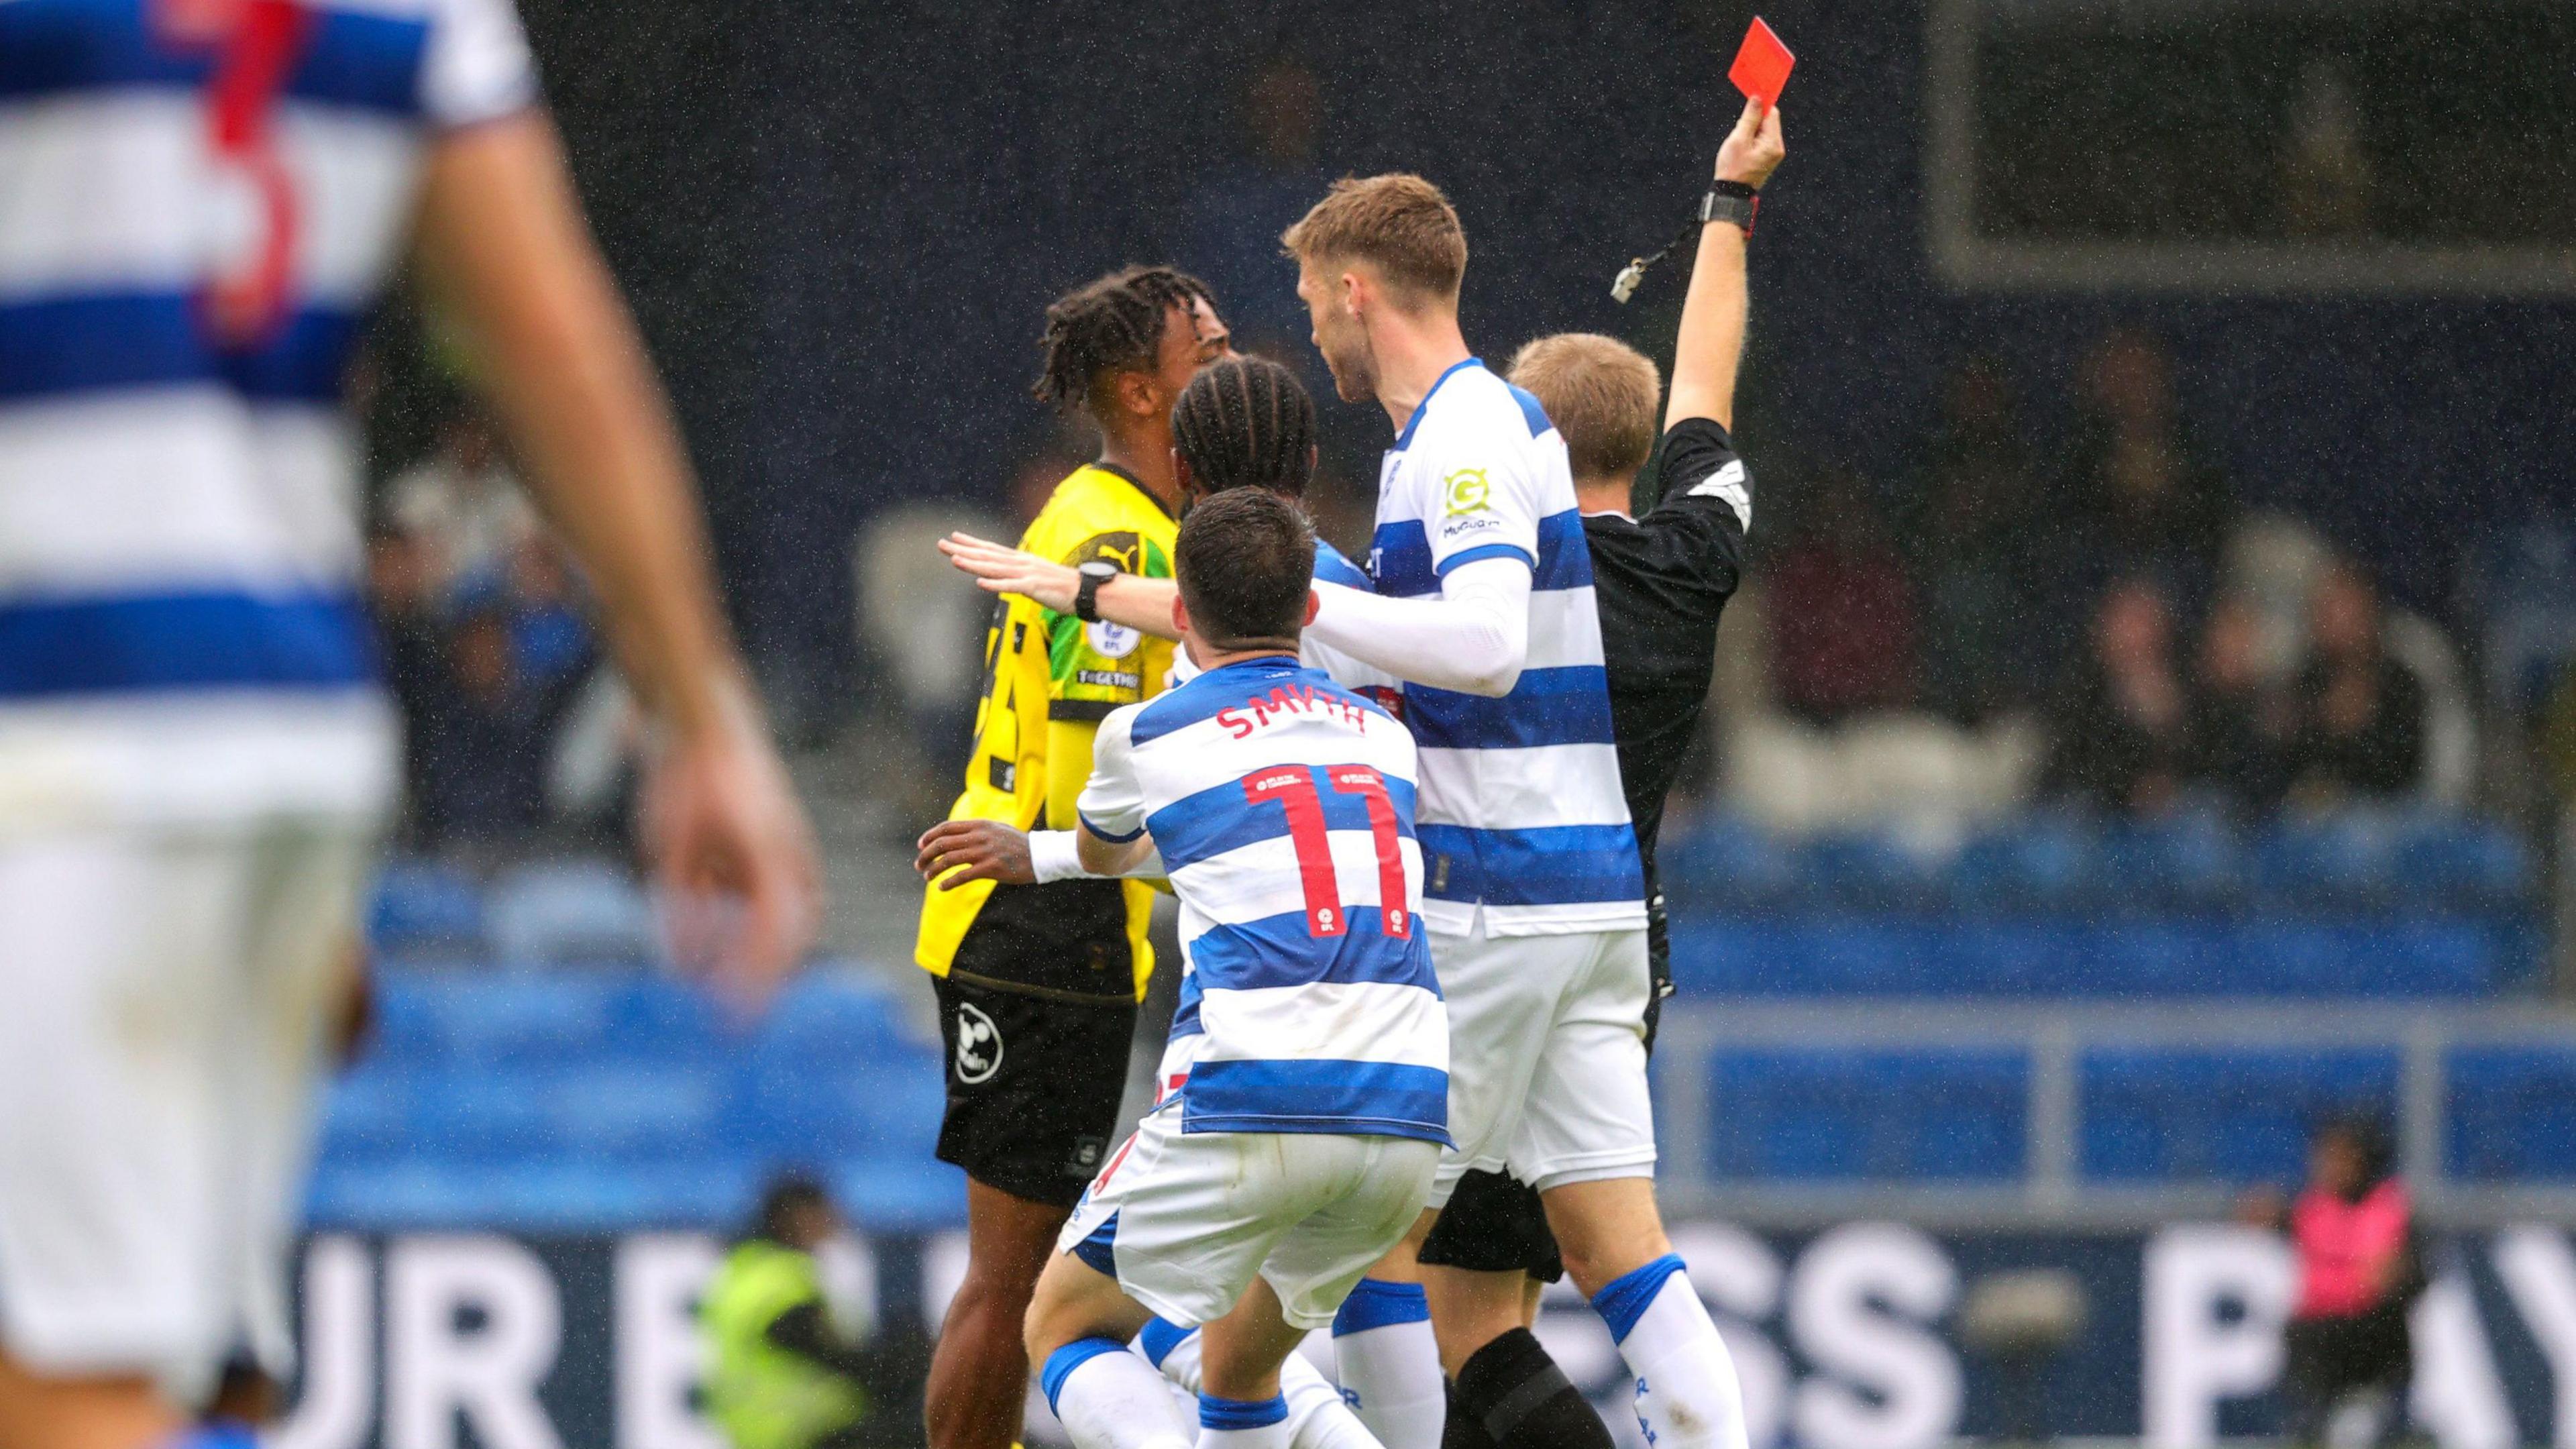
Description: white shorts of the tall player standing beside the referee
1432,913,1654,1207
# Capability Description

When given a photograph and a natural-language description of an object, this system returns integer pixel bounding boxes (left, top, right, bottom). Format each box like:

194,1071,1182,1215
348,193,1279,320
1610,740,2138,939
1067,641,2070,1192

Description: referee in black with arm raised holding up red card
1422,101,1785,1449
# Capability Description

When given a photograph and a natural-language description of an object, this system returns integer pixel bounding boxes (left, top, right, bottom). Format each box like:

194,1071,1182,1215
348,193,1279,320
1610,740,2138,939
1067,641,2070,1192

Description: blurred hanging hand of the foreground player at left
644,709,822,1008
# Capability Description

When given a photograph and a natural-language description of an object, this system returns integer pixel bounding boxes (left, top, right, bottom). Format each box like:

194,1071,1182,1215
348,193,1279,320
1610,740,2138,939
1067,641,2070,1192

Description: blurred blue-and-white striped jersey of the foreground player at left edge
0,0,536,828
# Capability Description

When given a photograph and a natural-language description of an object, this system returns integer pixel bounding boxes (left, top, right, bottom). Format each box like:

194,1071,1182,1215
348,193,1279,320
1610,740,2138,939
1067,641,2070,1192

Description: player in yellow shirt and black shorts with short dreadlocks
914,266,1232,1449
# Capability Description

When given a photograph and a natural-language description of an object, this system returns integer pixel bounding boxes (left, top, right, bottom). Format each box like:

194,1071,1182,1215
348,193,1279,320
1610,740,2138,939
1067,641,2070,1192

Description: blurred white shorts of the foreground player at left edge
0,822,374,1392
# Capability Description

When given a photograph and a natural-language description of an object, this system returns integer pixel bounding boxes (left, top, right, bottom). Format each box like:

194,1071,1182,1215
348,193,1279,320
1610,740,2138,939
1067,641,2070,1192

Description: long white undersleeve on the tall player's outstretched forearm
1306,551,1530,699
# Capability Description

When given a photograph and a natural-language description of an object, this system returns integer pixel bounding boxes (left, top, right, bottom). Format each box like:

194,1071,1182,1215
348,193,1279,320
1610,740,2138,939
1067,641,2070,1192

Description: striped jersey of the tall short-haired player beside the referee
1368,358,1646,936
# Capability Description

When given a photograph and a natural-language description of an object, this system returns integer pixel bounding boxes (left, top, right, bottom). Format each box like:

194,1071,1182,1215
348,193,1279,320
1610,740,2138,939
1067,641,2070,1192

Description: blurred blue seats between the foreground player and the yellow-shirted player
312,967,963,1232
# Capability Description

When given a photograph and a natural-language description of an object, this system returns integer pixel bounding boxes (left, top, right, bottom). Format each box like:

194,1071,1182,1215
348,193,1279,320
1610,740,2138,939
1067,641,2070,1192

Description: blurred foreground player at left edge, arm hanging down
0,0,816,1449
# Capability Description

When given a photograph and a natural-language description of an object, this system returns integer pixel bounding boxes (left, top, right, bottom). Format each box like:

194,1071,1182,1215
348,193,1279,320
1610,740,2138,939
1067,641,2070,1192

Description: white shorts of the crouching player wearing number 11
1056,1101,1440,1328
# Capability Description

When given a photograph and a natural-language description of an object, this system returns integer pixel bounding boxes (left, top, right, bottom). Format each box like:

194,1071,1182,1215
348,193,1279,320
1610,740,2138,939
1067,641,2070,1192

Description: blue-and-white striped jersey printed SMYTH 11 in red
1079,655,1448,1142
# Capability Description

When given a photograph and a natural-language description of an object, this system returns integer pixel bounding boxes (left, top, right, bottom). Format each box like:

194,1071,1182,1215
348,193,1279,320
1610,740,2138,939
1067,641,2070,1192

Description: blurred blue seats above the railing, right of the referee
1662,812,2542,998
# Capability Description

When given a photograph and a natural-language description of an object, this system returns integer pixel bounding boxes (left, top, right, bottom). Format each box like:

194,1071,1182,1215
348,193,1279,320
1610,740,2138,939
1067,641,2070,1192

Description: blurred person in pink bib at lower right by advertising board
2244,1116,2424,1449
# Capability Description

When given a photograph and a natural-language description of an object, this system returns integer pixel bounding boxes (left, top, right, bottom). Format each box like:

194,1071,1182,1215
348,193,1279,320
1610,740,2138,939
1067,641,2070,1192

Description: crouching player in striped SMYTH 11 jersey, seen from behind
1028,487,1448,1449
